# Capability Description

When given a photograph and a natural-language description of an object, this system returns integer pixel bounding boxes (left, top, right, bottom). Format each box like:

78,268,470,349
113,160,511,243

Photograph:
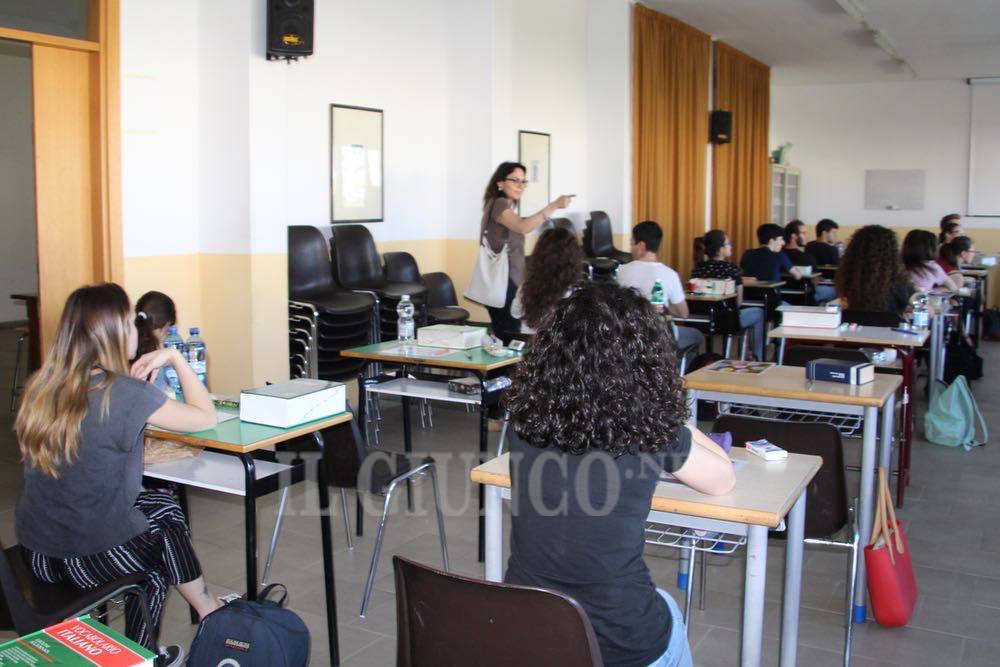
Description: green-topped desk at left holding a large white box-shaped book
144,412,351,665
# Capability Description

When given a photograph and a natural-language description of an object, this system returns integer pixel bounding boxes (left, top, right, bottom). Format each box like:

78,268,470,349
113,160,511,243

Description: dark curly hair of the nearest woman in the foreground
504,282,688,457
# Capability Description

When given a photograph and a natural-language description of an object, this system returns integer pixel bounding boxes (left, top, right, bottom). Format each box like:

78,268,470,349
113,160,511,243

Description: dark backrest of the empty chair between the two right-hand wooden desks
713,415,849,537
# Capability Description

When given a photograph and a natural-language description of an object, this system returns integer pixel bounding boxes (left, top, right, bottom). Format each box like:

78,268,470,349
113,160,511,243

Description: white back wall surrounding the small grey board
771,81,1000,228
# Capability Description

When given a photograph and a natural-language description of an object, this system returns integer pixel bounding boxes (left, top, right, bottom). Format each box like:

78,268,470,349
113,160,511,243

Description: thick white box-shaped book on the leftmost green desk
240,378,347,428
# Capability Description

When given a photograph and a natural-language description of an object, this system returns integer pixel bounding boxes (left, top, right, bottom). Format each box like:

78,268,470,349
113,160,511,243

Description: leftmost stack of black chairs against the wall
288,225,378,381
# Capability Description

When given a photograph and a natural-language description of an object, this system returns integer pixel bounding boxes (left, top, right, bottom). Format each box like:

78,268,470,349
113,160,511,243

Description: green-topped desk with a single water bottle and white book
340,340,521,561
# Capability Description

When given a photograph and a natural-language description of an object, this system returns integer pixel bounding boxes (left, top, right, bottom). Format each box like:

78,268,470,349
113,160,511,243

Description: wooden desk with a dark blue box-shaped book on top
682,366,903,623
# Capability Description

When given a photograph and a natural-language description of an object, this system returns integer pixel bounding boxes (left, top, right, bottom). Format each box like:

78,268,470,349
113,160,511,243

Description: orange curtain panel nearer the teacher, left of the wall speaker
632,4,712,280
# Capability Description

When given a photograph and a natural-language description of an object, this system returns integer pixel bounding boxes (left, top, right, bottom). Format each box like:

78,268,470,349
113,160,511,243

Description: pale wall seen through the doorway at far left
0,41,38,322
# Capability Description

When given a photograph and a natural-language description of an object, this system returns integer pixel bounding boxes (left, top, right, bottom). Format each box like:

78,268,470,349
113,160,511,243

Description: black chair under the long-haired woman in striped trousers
0,544,156,652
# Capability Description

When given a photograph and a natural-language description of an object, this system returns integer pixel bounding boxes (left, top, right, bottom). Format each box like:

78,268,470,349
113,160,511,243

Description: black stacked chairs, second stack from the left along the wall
330,225,427,340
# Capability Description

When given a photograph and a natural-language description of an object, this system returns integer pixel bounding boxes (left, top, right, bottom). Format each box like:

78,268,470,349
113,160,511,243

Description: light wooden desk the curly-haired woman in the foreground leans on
471,448,823,667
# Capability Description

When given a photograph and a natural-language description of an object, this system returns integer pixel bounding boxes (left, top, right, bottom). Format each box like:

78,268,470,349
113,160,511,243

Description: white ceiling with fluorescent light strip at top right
642,0,1000,85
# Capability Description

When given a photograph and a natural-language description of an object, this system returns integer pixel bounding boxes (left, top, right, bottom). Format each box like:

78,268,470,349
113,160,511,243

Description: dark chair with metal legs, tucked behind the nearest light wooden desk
702,415,861,664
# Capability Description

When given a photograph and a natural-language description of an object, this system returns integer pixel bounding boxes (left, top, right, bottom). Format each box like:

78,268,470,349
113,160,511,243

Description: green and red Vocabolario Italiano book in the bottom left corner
0,616,156,667
